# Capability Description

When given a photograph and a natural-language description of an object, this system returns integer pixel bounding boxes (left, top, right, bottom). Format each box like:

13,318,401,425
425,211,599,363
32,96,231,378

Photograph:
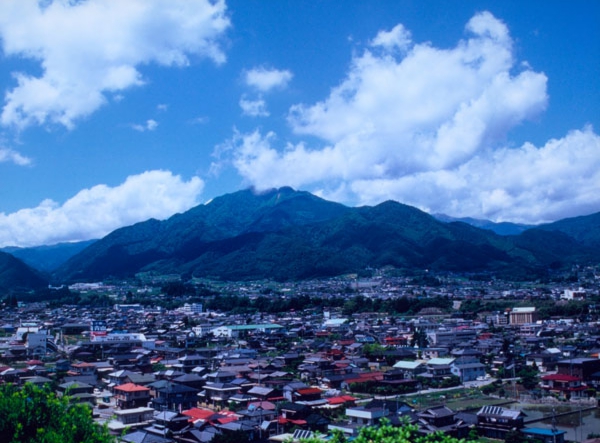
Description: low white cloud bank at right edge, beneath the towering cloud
352,127,600,223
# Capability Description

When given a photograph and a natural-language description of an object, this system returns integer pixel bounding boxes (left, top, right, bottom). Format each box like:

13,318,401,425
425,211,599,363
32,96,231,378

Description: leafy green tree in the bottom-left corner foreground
0,383,115,443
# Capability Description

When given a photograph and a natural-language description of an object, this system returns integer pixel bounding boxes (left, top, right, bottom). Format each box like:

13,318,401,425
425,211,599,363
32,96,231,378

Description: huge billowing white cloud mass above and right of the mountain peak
227,12,600,222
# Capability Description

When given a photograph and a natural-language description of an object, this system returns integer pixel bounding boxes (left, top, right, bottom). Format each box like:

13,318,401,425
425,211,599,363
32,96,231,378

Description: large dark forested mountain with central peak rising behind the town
55,188,600,282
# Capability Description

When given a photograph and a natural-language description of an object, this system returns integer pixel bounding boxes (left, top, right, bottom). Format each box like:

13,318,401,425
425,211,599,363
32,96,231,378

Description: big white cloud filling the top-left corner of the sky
0,0,229,129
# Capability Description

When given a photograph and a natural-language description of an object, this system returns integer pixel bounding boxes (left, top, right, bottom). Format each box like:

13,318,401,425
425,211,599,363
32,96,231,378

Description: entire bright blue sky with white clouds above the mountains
0,0,600,246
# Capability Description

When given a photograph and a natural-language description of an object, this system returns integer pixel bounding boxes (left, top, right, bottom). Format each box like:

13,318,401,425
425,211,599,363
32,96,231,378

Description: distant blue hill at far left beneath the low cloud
0,240,96,272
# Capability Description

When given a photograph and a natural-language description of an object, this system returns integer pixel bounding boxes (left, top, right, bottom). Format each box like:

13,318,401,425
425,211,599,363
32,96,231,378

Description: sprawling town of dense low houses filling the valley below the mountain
0,268,600,443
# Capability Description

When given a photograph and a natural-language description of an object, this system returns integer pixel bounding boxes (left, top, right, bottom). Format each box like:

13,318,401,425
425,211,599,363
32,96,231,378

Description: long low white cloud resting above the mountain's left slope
0,171,204,247
